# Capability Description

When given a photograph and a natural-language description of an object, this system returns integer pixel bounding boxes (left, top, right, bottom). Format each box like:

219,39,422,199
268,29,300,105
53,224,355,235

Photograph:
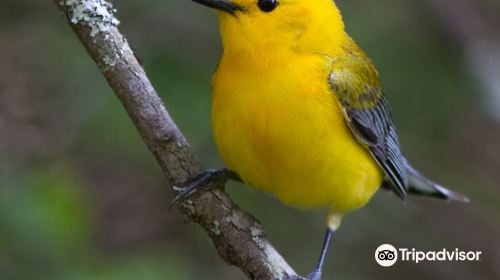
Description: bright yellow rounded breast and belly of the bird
212,51,383,213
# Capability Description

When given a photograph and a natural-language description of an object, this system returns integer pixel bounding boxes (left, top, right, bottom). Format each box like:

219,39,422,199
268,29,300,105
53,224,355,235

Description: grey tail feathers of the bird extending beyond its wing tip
405,160,469,202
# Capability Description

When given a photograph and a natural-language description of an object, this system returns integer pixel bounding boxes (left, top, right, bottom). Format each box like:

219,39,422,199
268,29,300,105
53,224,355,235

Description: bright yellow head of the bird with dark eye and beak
193,0,346,53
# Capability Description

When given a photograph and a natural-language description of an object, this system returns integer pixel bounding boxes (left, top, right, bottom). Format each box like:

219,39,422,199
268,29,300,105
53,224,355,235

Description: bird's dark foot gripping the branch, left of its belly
170,168,238,208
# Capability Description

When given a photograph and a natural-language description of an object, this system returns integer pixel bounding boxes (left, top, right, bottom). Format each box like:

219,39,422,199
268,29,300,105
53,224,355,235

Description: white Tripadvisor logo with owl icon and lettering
375,244,482,267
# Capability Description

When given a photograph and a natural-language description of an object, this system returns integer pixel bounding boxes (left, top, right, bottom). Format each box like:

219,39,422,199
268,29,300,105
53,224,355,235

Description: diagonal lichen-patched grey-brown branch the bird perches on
53,0,295,279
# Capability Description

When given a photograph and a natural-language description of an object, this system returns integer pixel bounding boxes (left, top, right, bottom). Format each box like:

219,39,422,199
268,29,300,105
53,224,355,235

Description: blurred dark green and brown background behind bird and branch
0,0,500,280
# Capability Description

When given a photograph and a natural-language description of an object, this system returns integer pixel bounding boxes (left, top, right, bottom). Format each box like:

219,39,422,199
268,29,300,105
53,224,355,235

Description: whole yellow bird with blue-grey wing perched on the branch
174,0,467,280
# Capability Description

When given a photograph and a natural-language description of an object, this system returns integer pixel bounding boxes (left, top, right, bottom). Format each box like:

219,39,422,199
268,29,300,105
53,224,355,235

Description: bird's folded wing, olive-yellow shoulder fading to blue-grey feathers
329,54,408,199
